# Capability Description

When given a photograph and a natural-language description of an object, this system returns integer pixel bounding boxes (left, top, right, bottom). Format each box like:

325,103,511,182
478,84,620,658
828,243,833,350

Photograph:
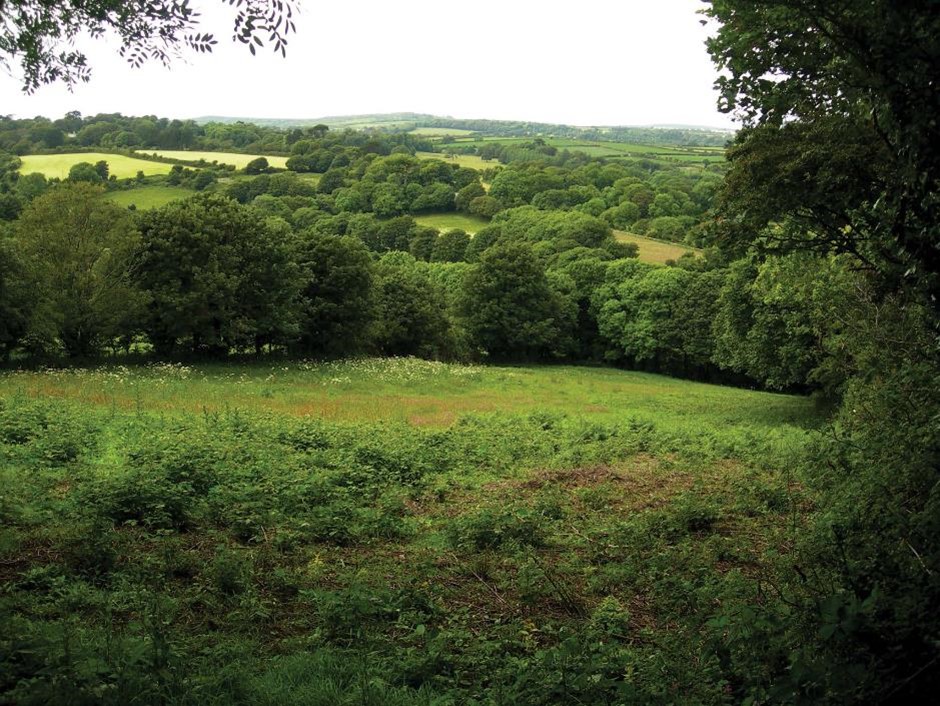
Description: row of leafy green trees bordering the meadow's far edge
0,175,857,408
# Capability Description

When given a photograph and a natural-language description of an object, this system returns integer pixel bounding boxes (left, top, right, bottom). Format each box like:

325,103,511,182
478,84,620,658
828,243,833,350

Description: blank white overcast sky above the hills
0,0,731,127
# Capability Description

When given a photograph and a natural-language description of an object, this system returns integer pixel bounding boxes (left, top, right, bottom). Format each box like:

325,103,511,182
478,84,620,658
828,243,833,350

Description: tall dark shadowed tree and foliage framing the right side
706,5,940,692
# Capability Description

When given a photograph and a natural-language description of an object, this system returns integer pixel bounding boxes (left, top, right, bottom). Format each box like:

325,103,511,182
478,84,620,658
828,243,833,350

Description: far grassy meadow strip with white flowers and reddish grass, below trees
0,359,810,428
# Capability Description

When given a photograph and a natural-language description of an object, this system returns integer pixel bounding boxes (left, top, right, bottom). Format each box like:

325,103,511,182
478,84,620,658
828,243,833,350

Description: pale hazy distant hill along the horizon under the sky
195,113,734,147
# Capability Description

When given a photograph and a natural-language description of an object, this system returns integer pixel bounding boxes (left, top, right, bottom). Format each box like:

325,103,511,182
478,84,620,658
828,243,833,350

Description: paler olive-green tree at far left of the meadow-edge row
16,183,141,357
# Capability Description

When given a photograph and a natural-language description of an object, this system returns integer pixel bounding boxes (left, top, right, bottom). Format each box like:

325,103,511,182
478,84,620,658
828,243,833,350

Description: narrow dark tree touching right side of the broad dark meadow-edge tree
298,233,374,355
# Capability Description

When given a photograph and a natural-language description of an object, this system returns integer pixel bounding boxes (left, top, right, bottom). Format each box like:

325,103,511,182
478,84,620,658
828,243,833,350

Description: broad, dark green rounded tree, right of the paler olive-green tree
134,194,300,354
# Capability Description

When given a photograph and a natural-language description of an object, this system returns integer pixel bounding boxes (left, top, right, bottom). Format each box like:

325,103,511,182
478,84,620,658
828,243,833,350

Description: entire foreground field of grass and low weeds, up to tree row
0,359,818,706
